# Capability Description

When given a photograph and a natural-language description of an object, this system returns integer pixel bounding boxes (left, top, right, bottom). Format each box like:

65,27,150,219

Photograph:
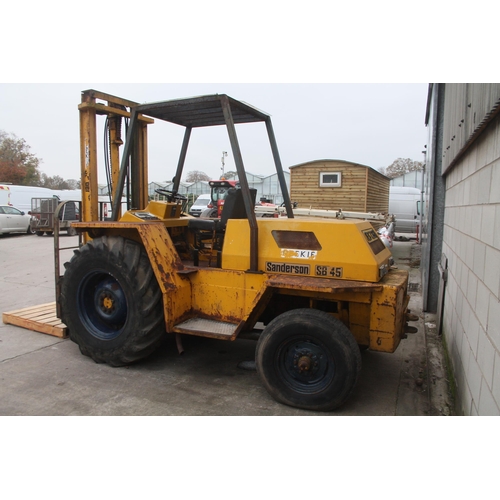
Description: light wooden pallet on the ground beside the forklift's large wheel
2,302,68,339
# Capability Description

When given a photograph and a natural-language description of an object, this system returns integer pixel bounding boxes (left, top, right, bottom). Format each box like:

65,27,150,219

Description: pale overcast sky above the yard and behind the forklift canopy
0,83,428,184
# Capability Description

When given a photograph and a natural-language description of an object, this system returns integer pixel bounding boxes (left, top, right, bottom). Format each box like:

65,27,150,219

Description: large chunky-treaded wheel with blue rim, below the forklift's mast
61,236,165,366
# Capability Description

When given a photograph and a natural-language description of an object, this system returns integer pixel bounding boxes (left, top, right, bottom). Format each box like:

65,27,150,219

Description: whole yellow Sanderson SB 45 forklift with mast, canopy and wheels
56,90,411,411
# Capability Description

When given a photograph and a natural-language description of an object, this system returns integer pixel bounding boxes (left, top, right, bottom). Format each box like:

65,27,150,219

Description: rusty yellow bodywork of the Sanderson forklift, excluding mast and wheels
71,202,408,352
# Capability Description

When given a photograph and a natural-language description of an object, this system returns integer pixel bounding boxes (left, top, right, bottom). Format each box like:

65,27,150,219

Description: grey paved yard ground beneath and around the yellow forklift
0,230,453,416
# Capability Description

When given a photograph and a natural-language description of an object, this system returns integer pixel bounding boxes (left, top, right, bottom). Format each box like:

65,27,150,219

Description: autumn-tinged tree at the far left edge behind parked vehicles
0,130,42,186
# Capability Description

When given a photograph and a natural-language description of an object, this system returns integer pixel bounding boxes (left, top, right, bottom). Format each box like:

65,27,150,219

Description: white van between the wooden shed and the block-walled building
389,186,421,233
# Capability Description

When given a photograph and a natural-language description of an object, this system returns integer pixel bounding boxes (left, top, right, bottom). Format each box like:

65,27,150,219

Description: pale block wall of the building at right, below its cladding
443,115,500,415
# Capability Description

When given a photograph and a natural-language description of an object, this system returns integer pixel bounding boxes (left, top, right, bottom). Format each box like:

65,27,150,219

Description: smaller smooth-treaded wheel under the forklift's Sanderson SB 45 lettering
256,309,361,411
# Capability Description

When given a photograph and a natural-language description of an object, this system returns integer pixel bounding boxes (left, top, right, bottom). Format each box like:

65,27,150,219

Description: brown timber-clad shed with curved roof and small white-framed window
290,160,390,213
